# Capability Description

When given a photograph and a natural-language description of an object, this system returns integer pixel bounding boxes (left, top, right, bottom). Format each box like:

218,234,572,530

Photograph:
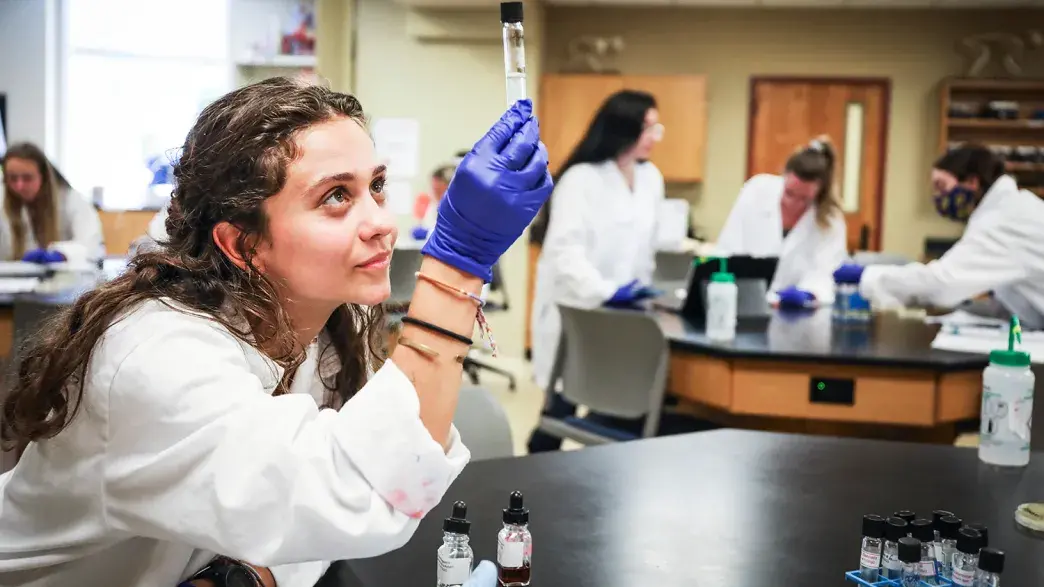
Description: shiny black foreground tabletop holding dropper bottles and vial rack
342,430,1044,587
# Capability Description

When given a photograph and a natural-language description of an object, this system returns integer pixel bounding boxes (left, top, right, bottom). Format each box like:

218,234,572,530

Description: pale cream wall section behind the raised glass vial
346,0,543,356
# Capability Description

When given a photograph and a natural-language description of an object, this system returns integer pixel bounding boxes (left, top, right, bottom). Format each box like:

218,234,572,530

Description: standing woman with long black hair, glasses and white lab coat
529,90,664,452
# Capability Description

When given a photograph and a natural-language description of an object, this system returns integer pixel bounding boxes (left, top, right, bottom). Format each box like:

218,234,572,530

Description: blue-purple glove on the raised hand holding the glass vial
421,100,553,283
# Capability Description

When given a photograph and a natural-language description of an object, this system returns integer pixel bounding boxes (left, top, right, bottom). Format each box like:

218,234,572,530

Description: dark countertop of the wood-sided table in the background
657,309,988,371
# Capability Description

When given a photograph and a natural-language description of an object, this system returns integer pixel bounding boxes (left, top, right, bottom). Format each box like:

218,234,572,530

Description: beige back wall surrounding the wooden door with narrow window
545,7,1044,256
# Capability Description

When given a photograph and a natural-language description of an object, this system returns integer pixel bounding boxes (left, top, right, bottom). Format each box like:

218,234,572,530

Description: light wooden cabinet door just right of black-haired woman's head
623,75,707,183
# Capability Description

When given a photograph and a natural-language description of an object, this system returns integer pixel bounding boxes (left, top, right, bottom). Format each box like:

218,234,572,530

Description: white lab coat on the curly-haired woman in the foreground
0,301,470,587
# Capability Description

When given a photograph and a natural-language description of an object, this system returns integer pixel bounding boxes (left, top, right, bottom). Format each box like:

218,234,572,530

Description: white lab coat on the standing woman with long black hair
531,161,664,389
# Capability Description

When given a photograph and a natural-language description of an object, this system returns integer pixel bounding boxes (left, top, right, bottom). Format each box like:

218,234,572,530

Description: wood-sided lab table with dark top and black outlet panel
657,309,987,443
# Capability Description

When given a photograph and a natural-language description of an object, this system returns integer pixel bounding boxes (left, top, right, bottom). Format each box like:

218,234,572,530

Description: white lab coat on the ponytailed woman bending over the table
715,174,848,305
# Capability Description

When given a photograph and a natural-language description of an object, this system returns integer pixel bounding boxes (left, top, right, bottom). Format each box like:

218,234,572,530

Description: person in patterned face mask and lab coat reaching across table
838,145,1044,329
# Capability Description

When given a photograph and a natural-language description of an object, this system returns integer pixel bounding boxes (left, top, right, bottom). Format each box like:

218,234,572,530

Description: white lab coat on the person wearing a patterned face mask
859,175,1044,329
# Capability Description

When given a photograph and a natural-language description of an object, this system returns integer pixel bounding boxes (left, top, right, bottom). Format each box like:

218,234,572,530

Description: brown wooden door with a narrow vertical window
748,77,892,251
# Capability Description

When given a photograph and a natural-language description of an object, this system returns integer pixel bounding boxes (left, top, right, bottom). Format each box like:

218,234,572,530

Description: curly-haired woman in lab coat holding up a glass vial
0,77,551,587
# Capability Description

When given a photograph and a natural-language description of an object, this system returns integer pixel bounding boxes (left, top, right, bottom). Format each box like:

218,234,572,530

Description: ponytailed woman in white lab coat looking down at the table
716,137,847,307
